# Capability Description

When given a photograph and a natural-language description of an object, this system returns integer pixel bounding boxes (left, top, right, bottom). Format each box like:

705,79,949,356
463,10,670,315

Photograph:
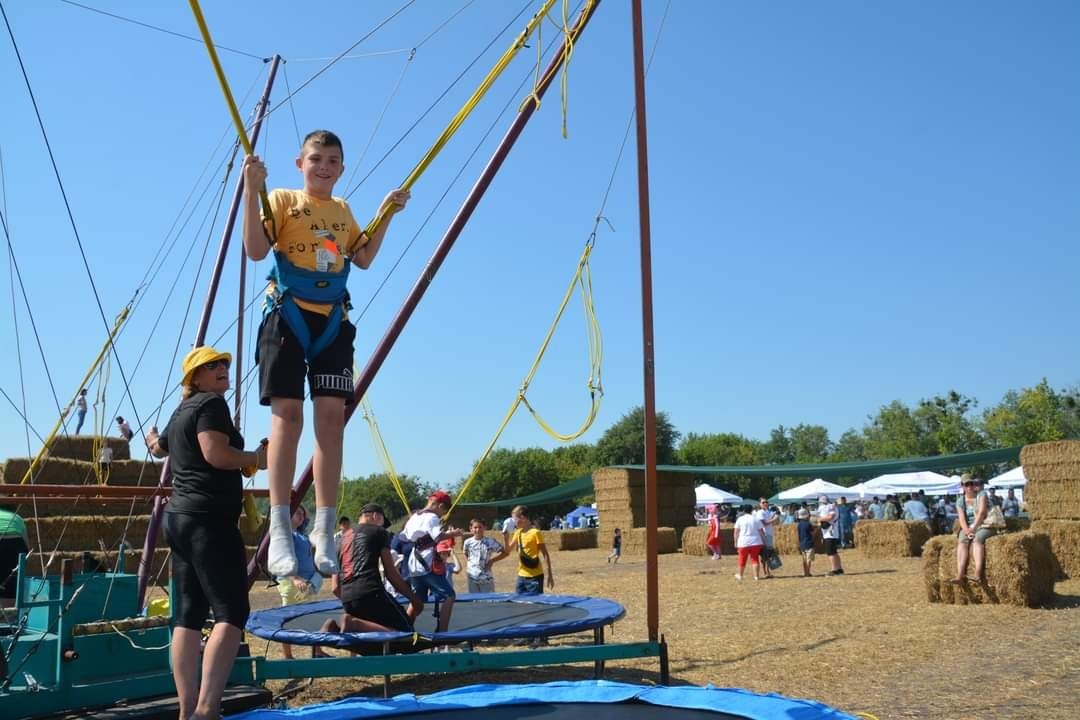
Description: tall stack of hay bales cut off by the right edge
1020,440,1080,578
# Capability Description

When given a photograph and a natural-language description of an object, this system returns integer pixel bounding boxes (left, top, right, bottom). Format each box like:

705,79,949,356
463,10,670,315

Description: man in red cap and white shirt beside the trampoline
402,490,464,633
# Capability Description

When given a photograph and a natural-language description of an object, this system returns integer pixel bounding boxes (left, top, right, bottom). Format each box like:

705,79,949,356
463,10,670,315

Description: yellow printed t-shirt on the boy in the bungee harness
264,188,367,315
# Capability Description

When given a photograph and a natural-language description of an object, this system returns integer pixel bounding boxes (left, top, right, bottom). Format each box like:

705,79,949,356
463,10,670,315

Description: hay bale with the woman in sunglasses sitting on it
922,530,1054,608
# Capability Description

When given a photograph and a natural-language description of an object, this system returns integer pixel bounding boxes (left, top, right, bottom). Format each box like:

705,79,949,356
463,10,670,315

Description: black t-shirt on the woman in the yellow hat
158,393,244,521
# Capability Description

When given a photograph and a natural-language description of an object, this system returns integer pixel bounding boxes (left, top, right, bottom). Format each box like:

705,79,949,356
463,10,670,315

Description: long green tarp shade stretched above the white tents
615,445,1023,479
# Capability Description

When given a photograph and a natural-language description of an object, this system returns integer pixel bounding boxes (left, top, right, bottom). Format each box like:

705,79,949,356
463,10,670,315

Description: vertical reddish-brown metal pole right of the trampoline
631,0,660,642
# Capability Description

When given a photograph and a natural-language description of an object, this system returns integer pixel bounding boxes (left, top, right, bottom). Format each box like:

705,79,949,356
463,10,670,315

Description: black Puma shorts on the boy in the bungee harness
256,310,356,405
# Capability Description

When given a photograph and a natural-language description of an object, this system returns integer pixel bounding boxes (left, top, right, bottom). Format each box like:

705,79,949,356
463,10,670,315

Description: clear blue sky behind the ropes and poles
0,0,1080,485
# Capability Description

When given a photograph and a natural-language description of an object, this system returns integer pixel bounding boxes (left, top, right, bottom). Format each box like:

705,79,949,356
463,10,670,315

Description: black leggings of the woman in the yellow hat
165,513,251,630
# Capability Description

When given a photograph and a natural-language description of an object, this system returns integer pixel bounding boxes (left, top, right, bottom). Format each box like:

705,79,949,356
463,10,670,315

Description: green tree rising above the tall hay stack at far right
982,378,1080,447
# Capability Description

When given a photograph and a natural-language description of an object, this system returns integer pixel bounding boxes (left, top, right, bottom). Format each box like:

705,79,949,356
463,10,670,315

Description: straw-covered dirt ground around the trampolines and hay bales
249,549,1080,720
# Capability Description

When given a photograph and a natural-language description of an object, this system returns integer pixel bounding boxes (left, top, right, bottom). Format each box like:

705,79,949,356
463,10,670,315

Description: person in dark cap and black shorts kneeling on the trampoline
322,503,423,633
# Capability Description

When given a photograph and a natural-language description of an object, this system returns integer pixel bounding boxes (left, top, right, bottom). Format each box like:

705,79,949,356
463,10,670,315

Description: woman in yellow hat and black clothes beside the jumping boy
146,345,267,720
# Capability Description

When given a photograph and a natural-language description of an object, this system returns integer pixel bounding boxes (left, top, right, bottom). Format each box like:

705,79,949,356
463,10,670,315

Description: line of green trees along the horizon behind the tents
332,380,1080,520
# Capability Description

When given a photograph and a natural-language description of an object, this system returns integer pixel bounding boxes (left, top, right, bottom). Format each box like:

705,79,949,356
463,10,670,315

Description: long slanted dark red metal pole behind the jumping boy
247,0,599,587
